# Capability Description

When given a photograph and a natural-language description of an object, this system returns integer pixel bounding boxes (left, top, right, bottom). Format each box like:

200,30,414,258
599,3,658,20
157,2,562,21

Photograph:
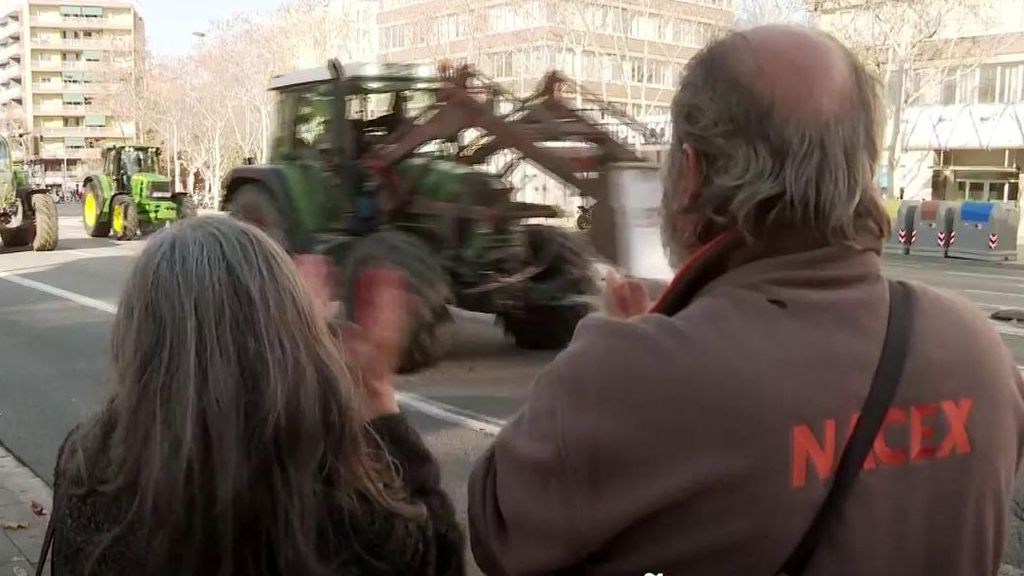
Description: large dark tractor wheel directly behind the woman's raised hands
339,231,455,373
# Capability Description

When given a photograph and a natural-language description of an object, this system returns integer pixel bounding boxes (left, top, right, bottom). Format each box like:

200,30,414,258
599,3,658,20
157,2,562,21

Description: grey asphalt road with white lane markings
0,205,1024,569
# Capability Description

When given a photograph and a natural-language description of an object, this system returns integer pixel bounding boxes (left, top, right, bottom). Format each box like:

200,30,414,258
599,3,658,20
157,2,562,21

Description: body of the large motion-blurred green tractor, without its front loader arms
220,60,598,372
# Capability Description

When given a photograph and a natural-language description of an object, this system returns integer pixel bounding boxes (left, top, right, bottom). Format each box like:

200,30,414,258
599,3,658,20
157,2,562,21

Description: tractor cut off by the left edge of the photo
0,135,57,252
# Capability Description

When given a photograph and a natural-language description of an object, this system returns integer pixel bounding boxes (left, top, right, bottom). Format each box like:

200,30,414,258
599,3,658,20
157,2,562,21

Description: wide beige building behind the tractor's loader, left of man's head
379,0,735,127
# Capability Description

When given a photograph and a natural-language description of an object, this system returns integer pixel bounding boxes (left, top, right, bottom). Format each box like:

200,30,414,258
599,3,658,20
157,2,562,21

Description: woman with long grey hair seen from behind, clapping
52,217,463,576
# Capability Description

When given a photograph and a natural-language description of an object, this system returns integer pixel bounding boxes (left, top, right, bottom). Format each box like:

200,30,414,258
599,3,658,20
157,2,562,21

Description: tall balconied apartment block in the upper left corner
0,0,144,188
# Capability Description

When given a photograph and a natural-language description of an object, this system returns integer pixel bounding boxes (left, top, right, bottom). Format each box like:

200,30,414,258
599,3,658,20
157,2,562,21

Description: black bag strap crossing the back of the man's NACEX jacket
778,281,913,576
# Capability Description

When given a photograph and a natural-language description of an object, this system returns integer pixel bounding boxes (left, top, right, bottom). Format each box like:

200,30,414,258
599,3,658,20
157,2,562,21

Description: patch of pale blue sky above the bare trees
136,0,284,55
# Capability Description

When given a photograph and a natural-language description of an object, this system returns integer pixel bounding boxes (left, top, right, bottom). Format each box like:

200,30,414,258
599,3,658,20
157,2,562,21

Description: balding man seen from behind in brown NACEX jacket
469,27,1024,576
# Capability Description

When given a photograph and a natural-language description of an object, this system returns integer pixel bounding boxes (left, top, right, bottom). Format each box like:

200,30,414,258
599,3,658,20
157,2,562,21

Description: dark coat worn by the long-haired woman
52,414,465,576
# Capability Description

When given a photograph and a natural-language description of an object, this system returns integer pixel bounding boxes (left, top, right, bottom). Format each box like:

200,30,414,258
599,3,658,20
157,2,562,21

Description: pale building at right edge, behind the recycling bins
812,0,1024,206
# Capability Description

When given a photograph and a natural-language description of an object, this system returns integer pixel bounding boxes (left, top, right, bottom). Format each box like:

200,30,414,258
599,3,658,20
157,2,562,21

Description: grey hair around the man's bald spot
665,27,890,245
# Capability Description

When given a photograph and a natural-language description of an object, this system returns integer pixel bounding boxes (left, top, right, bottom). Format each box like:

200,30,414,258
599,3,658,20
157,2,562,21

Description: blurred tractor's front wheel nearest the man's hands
500,225,598,349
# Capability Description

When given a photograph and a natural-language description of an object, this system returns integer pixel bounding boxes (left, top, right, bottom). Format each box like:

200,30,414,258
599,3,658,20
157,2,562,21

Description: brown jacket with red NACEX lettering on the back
469,238,1024,576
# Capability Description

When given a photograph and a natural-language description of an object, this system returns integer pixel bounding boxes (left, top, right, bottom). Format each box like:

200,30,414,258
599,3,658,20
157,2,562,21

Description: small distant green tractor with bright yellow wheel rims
82,145,196,240
